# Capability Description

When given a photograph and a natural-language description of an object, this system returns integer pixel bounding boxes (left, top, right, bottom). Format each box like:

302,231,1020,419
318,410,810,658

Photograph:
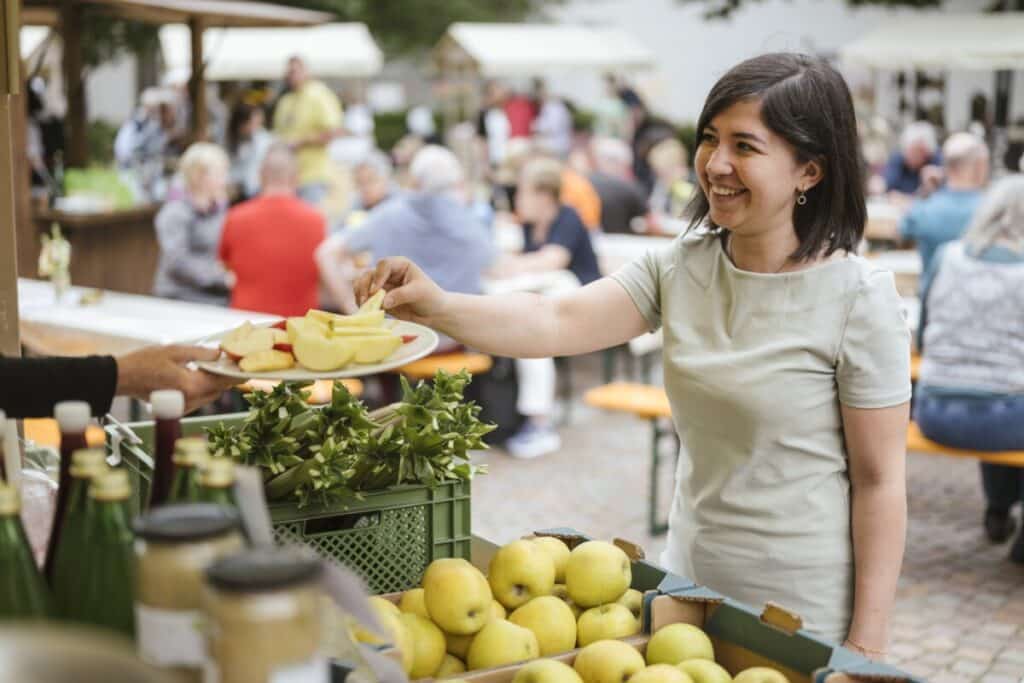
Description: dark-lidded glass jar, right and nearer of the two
203,548,328,683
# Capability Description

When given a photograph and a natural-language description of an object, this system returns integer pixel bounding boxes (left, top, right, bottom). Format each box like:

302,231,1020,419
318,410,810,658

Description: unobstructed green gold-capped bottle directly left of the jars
66,470,135,638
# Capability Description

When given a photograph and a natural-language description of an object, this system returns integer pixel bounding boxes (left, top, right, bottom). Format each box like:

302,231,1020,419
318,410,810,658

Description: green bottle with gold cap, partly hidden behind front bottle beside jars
52,449,108,616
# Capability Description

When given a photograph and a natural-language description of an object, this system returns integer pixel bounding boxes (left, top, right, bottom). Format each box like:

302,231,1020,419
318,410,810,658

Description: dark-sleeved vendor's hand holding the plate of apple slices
116,345,239,413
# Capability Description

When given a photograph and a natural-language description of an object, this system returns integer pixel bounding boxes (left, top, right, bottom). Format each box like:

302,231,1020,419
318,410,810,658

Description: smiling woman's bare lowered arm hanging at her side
842,403,909,658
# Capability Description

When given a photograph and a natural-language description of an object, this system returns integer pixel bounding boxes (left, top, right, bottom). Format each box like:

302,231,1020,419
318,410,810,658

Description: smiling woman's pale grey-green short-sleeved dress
612,233,910,640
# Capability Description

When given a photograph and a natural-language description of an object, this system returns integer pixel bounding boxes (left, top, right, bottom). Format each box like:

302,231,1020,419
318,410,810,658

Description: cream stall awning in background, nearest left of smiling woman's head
435,23,654,76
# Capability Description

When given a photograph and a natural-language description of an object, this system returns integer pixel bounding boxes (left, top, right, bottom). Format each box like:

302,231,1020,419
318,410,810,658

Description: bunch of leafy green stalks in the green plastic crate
207,371,495,507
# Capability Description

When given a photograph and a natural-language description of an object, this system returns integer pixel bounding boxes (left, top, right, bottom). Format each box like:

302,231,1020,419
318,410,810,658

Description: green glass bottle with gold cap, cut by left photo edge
0,482,51,621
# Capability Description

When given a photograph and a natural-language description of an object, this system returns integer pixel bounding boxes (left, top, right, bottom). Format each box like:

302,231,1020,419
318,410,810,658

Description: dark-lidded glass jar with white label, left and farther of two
135,503,244,683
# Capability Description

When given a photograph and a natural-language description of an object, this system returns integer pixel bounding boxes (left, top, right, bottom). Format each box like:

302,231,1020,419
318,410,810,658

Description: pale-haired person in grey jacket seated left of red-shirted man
153,142,229,306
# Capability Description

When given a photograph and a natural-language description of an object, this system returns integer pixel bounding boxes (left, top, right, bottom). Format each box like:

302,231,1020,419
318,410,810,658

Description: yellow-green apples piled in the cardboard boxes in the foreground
354,537,787,683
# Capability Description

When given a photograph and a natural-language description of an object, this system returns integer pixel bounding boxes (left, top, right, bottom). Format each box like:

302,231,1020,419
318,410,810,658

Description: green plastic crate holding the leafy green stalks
108,413,472,593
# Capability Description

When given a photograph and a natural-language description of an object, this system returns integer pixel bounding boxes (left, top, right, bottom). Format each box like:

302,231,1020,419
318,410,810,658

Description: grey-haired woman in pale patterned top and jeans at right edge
914,175,1024,564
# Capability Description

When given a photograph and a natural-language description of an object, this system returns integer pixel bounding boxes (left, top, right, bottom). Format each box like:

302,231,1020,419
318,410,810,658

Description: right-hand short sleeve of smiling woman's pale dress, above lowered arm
836,271,910,408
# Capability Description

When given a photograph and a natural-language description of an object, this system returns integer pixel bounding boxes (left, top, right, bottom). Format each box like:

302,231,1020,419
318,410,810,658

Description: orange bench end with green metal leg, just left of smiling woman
583,382,679,536
